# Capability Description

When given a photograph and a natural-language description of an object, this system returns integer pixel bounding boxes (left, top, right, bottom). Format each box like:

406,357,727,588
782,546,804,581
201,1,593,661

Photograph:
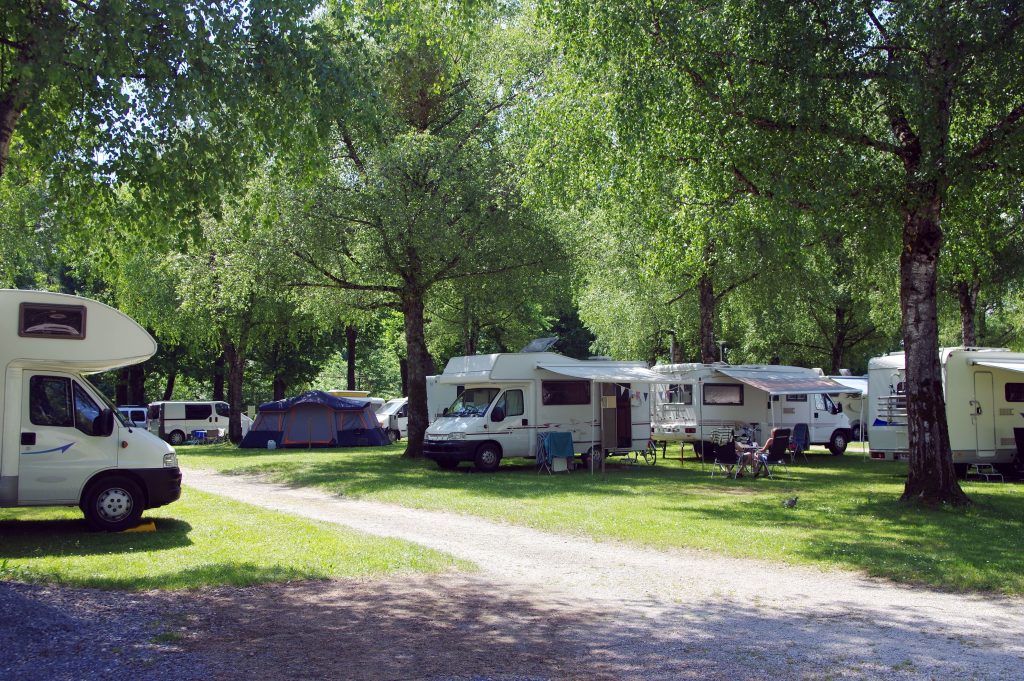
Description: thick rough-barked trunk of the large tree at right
900,193,970,505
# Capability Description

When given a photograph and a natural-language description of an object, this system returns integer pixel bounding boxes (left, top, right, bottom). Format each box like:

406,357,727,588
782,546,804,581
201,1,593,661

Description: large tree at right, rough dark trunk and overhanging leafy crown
550,0,1024,504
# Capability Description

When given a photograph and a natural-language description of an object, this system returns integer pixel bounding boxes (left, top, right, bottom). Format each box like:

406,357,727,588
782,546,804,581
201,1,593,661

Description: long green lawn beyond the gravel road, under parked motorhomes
178,443,1024,595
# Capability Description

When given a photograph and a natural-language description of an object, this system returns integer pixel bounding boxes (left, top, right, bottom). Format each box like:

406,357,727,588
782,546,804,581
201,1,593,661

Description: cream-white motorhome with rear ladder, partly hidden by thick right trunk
867,347,1024,476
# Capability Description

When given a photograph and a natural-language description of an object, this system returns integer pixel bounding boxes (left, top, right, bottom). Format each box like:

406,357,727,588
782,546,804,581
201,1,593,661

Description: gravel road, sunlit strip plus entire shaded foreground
0,470,1024,681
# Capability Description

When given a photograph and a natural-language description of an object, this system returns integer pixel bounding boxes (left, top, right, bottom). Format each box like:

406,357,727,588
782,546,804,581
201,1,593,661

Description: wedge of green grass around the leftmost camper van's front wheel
0,487,471,590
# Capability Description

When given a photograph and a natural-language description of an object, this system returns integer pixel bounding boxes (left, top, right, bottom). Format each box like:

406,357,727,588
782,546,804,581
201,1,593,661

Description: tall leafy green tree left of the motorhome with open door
292,3,557,457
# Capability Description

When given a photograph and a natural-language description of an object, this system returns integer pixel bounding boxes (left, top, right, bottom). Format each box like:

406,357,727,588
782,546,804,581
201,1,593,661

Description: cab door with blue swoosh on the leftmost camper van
17,372,117,503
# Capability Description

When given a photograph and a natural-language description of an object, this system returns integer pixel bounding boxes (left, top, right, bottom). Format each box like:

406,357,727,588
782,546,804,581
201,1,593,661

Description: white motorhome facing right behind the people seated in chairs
651,363,851,455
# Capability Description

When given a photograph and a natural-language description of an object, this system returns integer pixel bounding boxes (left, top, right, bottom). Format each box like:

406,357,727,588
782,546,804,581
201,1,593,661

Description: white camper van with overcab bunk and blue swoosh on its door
0,290,181,531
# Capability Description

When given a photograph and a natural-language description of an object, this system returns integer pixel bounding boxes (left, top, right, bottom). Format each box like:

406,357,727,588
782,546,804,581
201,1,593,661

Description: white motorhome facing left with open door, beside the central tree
424,352,658,471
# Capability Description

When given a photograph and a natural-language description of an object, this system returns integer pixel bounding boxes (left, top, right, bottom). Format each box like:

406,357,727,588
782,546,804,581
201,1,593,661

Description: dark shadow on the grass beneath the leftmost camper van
0,518,193,560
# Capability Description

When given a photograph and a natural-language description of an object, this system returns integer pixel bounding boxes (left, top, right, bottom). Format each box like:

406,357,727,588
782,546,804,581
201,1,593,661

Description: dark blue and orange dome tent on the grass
239,390,388,449
